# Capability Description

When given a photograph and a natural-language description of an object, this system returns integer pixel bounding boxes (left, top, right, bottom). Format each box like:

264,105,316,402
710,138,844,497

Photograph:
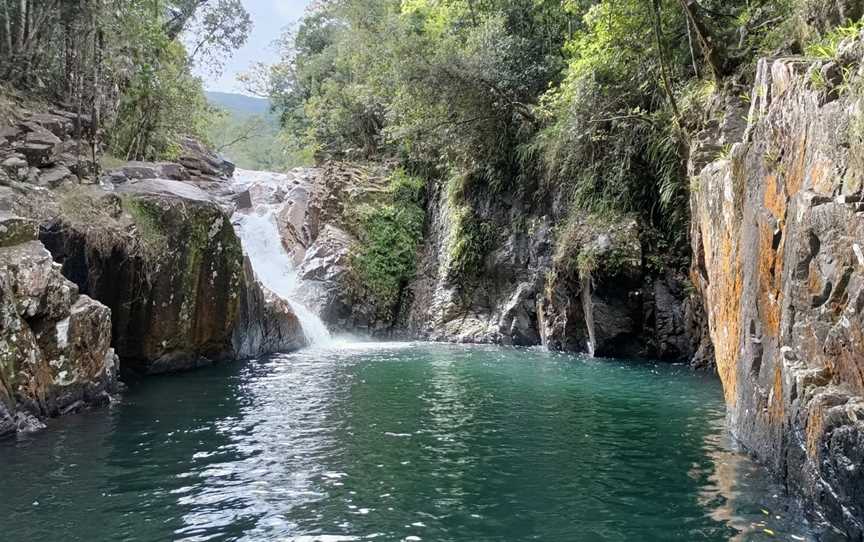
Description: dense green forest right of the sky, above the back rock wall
250,0,848,294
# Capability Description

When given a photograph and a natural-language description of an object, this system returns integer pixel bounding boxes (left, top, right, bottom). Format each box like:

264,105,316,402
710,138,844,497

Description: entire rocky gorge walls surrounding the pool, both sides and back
0,26,864,540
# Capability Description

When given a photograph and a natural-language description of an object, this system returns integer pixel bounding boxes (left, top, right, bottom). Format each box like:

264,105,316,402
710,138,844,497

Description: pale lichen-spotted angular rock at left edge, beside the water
0,241,117,435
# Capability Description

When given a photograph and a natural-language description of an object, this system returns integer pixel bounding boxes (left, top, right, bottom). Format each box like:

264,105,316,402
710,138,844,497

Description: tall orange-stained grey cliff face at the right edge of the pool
691,51,864,540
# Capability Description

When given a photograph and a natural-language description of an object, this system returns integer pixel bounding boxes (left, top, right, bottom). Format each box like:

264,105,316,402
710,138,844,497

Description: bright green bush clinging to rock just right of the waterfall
351,169,425,317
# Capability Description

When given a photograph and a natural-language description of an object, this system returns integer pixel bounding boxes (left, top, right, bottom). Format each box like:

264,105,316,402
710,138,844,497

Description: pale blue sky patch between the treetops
199,0,310,93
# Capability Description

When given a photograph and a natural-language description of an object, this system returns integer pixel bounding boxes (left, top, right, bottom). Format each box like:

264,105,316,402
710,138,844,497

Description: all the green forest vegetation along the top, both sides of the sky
0,0,851,298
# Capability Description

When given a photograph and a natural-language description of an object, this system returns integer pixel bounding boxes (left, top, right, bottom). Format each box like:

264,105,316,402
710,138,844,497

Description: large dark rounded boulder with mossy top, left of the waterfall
42,179,243,373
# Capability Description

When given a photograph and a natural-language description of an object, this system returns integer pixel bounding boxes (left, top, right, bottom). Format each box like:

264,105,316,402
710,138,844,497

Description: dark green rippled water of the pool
0,344,810,542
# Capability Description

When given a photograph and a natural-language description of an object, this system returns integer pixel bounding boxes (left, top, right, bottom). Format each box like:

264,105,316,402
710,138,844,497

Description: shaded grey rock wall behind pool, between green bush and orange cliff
408,174,710,361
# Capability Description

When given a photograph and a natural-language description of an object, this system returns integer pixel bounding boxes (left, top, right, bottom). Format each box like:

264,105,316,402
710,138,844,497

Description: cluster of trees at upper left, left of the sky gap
0,0,251,160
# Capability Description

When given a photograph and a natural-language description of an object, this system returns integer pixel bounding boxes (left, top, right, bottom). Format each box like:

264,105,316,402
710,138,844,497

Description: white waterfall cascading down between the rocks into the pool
234,180,331,346
